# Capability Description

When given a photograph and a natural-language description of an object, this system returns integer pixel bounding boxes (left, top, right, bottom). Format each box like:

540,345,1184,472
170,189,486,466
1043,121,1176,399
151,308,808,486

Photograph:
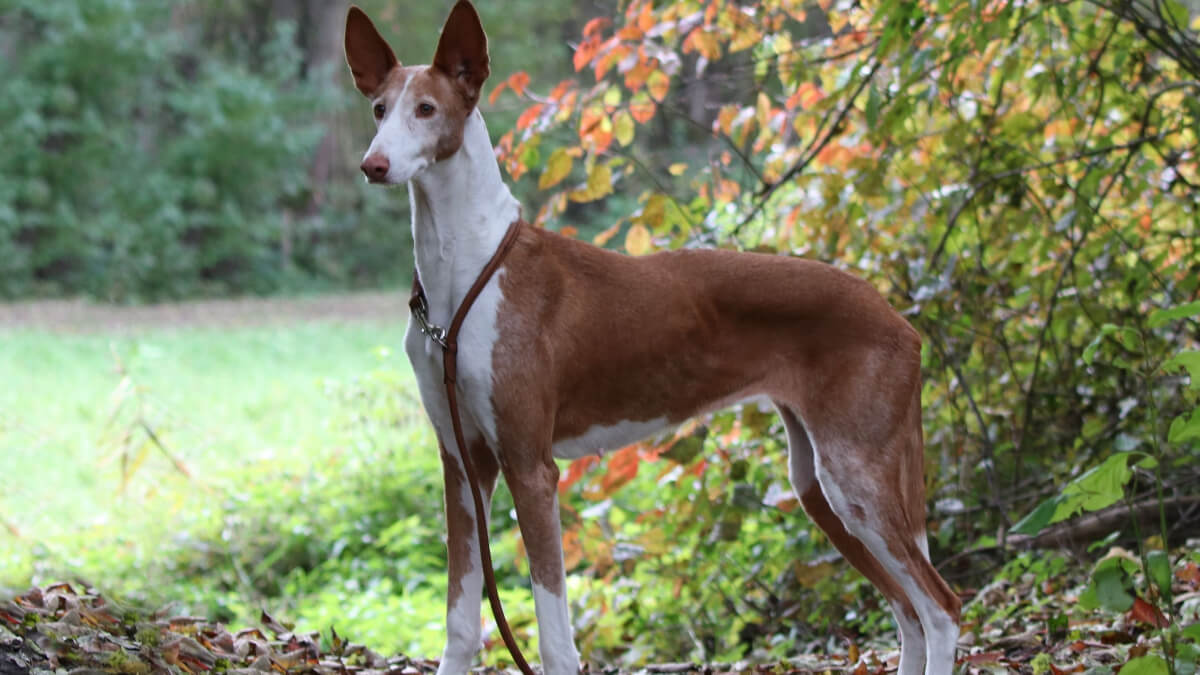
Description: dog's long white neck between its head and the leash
408,109,521,327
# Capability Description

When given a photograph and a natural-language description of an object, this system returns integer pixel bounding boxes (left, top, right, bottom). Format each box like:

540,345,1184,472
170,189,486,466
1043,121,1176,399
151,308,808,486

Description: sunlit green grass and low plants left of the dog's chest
0,321,542,656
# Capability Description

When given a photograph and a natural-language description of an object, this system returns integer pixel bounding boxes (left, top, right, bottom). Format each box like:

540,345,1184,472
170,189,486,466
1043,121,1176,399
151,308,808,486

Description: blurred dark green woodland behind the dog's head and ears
0,0,577,301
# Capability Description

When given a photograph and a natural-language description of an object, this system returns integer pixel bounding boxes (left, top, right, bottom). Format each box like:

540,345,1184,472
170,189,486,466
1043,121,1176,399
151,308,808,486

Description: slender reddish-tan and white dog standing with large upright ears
346,0,960,675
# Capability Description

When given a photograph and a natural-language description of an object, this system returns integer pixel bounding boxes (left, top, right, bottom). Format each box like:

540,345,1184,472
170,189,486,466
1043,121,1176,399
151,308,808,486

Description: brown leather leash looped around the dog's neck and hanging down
408,219,534,675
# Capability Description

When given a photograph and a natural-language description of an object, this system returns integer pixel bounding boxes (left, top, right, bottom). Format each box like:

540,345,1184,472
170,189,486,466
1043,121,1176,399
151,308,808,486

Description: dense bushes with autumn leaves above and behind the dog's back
500,0,1200,552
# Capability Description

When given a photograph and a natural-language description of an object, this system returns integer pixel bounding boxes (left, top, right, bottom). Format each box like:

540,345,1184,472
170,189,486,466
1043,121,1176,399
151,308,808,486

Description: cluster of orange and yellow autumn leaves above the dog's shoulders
490,0,874,255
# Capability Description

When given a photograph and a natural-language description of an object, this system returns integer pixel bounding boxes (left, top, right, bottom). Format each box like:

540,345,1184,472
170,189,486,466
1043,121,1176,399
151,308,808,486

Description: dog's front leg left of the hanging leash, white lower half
438,443,499,675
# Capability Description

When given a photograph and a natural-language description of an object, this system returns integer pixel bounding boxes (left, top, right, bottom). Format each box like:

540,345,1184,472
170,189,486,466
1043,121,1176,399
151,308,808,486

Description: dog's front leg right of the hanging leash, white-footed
504,448,580,675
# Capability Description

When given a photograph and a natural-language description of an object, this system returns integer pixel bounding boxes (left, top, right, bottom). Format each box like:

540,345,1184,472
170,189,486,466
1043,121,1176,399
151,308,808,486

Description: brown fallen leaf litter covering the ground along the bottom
0,562,1200,675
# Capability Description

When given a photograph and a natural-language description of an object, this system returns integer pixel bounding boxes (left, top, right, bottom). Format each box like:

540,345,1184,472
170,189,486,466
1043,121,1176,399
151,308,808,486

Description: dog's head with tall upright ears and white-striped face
346,0,490,184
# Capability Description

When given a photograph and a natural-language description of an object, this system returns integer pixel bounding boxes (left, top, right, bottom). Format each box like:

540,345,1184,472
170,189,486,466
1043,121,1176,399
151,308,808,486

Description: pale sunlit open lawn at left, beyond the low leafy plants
0,322,403,538
